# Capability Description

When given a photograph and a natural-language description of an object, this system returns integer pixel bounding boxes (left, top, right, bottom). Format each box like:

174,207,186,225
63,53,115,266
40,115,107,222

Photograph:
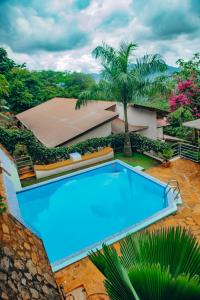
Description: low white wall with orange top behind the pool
34,147,114,179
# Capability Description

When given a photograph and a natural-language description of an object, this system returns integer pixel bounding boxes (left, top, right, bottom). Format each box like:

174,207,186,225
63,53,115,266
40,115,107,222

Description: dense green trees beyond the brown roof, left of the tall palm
0,48,95,113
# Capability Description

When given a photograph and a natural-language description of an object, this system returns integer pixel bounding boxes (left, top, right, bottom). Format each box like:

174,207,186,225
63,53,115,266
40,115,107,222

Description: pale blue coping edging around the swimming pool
17,159,181,272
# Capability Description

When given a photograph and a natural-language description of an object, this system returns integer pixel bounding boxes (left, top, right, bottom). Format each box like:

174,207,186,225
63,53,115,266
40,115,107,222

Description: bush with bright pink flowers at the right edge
169,79,200,118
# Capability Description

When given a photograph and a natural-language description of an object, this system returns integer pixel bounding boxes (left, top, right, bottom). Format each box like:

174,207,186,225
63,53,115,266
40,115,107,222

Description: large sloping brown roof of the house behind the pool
16,98,118,147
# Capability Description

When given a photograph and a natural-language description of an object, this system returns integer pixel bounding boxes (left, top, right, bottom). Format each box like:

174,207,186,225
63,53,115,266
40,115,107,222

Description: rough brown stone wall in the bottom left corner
0,175,61,300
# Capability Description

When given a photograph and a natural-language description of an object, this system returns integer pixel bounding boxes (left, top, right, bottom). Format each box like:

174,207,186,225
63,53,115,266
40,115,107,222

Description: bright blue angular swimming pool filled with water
17,160,177,271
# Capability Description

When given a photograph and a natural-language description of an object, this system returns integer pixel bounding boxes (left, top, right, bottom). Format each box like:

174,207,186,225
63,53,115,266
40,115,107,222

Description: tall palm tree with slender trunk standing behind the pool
76,42,166,156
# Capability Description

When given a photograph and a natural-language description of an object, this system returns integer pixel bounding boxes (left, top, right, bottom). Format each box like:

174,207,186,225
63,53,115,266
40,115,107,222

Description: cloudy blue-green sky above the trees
0,0,200,72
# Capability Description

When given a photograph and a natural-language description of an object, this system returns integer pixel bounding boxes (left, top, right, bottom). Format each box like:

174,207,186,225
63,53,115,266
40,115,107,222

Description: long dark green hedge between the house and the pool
0,128,169,164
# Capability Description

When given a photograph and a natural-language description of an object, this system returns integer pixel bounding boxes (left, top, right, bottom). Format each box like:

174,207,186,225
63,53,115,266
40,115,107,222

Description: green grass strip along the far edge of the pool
22,153,159,187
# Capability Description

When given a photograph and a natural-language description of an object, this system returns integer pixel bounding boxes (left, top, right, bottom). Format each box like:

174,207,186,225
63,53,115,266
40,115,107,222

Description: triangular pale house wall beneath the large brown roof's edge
64,122,111,146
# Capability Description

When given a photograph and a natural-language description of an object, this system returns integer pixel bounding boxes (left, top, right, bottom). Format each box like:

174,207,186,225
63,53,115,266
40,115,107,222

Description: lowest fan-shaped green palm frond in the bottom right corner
128,263,200,300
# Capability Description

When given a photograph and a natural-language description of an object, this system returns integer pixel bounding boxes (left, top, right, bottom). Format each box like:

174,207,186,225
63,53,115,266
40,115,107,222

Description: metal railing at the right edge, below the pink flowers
171,142,200,162
